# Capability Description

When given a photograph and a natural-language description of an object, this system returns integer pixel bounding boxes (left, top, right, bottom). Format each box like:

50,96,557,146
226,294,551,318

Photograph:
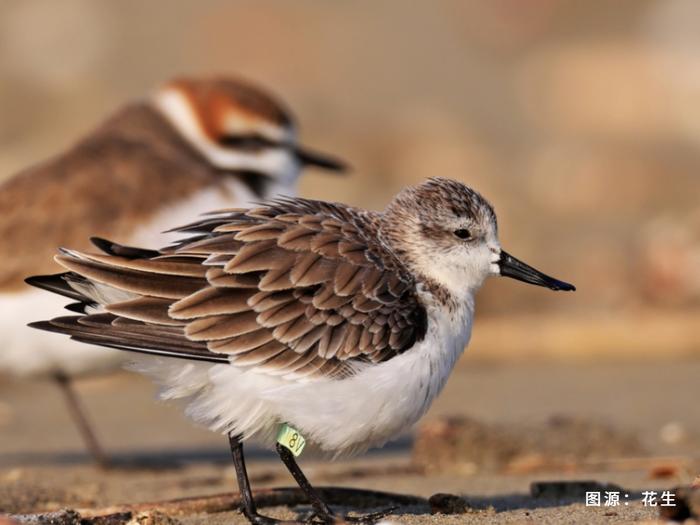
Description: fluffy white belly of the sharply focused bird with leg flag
132,302,471,455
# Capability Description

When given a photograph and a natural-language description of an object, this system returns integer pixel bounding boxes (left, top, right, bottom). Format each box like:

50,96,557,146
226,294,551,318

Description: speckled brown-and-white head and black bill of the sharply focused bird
382,178,575,297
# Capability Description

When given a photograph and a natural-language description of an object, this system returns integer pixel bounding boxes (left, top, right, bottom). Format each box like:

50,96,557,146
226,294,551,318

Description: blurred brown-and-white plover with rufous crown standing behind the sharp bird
0,74,343,464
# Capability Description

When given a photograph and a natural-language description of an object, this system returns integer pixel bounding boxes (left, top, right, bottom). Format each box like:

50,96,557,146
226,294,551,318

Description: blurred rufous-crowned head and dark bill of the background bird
154,78,345,191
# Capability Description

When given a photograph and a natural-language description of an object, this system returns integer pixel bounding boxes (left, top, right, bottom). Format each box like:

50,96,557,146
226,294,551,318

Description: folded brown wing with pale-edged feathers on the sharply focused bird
39,199,425,380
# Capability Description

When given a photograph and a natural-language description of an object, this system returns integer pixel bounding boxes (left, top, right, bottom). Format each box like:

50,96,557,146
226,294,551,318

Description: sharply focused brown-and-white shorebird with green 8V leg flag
31,178,574,524
